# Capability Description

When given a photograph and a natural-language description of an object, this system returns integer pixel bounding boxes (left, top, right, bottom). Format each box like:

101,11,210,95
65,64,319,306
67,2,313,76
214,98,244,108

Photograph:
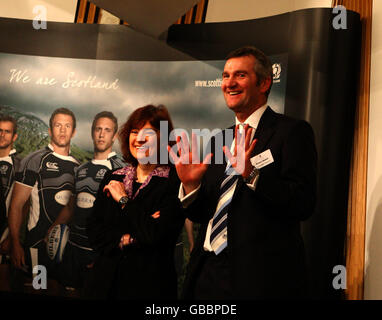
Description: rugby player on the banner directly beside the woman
55,111,126,289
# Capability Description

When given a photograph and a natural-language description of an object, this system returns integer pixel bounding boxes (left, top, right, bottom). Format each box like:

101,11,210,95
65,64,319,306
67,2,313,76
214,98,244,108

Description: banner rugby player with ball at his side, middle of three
8,108,79,289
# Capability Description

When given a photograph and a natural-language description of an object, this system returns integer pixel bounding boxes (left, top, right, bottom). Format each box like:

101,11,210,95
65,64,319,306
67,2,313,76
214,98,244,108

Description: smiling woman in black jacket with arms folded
85,105,184,299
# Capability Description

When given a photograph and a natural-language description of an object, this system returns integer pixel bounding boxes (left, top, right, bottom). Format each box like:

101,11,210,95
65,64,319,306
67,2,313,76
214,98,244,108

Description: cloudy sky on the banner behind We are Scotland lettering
0,53,287,151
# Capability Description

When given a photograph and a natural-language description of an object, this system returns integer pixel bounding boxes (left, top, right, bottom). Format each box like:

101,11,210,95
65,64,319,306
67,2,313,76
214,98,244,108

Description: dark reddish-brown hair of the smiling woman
119,104,175,166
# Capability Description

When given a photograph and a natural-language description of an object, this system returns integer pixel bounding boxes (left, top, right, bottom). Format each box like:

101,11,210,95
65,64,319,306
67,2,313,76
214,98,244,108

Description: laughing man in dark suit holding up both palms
169,47,317,299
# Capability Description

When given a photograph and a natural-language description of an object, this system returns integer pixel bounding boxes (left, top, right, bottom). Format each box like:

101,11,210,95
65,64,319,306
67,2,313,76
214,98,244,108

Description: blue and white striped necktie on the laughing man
210,164,238,255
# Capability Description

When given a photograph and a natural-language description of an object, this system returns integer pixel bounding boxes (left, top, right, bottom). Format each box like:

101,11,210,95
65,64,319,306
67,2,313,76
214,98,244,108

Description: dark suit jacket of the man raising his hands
184,107,317,299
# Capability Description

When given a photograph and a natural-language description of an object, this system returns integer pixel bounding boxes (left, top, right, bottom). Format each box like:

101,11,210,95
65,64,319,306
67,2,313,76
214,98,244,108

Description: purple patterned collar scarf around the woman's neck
113,165,170,199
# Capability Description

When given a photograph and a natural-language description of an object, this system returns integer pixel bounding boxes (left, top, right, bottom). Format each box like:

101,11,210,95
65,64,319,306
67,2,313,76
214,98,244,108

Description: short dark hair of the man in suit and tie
226,46,273,96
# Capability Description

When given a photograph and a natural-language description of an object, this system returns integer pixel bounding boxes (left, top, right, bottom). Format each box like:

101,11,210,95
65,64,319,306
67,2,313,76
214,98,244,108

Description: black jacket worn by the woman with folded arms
84,169,184,299
